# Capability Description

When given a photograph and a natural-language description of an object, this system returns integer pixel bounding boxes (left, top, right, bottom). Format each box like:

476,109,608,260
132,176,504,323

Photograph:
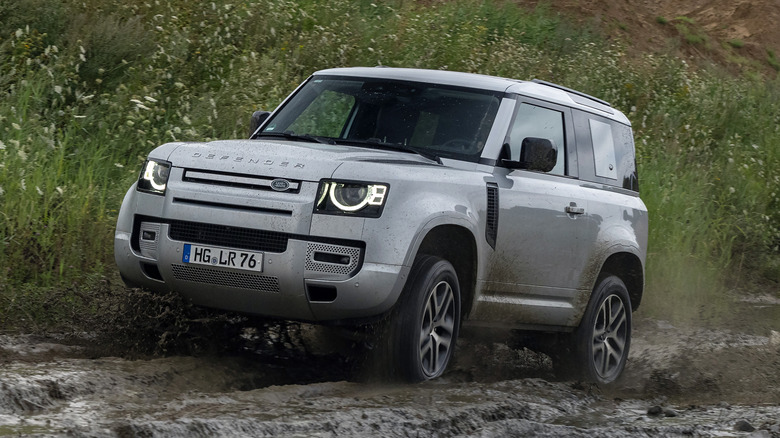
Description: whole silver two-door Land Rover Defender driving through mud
114,68,647,383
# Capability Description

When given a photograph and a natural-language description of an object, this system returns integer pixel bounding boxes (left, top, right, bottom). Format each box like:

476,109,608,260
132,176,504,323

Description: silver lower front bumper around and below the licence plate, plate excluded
114,216,408,322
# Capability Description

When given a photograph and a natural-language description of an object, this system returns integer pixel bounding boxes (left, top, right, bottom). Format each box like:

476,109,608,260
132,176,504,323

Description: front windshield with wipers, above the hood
260,76,500,161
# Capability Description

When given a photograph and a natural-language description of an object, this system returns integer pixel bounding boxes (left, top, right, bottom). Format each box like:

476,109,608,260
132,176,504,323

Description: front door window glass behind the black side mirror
509,103,566,175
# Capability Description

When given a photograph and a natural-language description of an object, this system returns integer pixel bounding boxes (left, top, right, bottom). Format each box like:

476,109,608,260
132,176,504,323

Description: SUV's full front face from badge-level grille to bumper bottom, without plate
114,168,410,322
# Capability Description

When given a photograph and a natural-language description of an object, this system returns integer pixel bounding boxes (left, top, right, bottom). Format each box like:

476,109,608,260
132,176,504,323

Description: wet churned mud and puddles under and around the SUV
0,296,780,438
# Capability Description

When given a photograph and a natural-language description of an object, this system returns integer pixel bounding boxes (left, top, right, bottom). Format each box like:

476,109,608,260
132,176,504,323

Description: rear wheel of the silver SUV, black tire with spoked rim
566,275,631,384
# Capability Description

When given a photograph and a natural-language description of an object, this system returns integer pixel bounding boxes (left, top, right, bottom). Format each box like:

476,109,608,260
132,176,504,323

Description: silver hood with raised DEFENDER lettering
154,140,439,181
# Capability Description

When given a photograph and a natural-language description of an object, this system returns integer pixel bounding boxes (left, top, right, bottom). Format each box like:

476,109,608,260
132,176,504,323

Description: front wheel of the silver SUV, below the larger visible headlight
388,255,460,382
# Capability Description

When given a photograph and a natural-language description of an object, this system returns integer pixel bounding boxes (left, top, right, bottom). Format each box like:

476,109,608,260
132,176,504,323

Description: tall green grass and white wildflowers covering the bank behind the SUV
0,0,780,328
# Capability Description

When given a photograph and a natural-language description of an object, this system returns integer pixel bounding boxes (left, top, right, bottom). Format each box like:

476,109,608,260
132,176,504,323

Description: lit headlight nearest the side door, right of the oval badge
314,181,388,217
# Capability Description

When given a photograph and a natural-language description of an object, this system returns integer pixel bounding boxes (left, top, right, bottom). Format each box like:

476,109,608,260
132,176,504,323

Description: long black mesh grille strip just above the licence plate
168,220,290,253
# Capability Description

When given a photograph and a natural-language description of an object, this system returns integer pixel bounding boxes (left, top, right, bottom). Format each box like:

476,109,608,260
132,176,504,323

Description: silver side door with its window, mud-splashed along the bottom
474,96,588,326
